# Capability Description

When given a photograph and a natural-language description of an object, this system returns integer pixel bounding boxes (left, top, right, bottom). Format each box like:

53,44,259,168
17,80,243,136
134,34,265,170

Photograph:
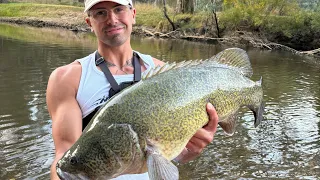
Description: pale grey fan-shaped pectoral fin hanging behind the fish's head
147,148,179,180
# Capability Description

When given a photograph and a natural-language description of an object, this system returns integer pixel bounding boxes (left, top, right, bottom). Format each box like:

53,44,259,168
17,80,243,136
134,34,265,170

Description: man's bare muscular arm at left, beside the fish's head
46,64,82,180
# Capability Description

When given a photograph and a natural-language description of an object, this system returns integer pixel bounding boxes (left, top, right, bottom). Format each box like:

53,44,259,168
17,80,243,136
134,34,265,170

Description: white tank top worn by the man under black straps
76,51,155,180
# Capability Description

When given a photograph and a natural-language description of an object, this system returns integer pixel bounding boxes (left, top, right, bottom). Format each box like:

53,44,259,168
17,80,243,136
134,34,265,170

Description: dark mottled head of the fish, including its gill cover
56,125,144,180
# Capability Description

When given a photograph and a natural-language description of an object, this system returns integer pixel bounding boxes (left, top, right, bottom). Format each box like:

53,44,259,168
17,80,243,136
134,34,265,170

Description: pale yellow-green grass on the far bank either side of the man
0,0,211,31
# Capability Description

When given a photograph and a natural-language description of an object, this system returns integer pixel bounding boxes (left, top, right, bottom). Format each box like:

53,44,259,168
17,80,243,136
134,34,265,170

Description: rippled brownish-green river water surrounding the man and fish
0,24,320,179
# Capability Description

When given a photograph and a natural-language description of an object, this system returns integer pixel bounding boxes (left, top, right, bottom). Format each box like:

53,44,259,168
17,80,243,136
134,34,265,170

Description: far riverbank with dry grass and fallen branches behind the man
0,4,320,57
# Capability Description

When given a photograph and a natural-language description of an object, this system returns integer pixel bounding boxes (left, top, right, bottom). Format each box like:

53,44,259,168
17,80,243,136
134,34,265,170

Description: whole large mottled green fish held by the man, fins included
57,48,264,180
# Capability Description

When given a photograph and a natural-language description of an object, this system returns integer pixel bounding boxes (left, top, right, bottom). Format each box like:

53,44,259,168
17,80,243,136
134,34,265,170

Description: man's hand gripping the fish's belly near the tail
175,103,219,163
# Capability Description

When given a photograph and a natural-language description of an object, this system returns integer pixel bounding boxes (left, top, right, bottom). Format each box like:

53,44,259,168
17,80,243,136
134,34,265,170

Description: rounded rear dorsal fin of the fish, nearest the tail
208,48,253,77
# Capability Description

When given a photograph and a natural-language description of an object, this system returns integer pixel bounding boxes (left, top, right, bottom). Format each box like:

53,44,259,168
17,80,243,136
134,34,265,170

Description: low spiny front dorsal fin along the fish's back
142,60,202,80
